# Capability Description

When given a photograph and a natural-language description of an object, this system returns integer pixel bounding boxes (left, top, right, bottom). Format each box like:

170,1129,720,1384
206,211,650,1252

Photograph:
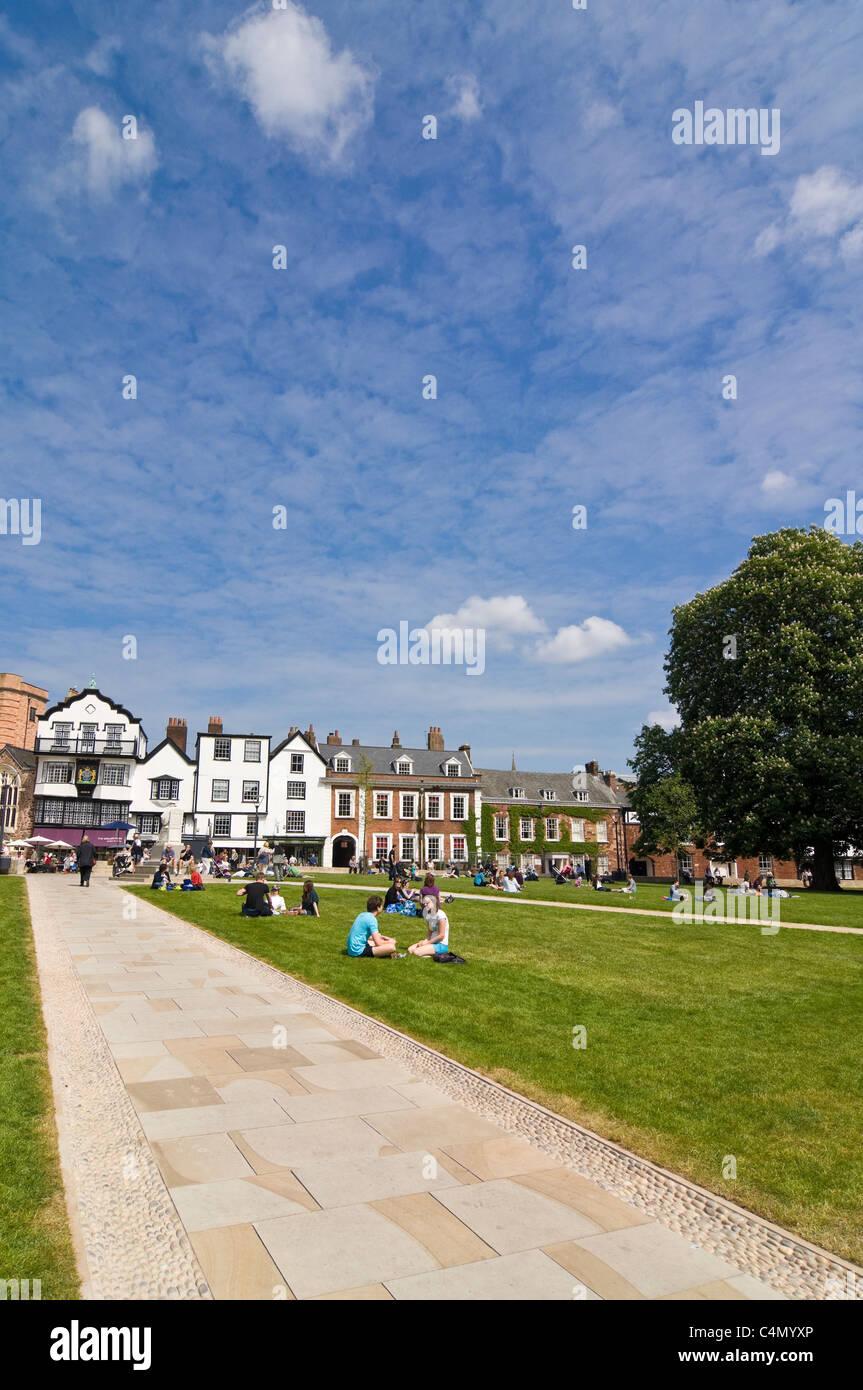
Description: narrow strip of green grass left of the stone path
0,877,78,1300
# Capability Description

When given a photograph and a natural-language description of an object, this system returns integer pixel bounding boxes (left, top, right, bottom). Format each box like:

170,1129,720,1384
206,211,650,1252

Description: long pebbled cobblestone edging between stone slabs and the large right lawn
136,898,863,1300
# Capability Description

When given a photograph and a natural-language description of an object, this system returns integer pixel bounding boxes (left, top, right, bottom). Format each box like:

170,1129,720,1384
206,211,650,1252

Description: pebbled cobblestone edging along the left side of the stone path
28,884,211,1300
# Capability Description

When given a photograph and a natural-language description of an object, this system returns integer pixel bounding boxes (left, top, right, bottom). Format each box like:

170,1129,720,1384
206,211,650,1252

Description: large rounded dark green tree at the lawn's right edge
666,527,863,888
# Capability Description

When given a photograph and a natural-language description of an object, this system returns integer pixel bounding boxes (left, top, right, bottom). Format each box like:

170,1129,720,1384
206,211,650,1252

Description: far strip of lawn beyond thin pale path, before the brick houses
280,870,863,927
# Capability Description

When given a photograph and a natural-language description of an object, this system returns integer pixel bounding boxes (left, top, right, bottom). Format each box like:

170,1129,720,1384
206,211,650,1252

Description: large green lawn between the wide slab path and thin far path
132,883,863,1259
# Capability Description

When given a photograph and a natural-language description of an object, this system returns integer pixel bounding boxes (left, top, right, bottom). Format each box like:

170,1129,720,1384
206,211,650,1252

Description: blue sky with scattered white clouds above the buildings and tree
0,0,863,769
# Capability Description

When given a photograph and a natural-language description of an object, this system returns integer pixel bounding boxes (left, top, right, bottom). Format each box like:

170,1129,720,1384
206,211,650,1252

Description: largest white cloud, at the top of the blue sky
204,0,374,164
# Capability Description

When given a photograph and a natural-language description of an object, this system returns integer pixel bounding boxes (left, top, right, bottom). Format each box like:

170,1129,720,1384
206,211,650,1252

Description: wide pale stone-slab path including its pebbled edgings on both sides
28,876,859,1300
